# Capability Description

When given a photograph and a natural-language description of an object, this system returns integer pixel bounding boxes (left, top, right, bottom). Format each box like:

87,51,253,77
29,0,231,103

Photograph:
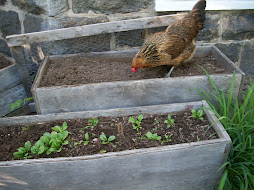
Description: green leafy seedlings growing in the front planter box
13,107,204,159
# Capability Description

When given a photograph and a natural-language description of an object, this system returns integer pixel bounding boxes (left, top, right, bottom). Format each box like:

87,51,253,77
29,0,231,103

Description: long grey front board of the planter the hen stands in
35,74,241,114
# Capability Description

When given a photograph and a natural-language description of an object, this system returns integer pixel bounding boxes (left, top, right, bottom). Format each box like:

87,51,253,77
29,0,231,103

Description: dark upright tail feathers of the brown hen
191,0,206,30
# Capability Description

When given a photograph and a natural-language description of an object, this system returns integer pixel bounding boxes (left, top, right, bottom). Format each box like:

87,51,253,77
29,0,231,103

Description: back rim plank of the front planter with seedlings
0,101,202,126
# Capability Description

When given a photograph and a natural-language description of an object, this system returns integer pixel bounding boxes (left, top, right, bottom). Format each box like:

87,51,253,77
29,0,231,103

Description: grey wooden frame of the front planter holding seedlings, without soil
0,101,231,190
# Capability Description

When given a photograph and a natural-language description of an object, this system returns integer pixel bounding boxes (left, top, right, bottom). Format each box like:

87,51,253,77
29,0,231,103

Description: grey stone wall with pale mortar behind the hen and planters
0,0,254,78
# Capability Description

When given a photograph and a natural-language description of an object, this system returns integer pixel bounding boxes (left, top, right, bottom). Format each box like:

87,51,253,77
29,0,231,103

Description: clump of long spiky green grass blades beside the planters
193,71,254,190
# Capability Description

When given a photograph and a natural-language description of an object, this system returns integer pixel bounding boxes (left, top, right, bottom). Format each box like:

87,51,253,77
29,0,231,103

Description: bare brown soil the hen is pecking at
40,56,232,87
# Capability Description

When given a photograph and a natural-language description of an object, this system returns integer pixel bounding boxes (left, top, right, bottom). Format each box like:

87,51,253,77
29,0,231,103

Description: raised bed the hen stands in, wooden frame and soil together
32,46,244,114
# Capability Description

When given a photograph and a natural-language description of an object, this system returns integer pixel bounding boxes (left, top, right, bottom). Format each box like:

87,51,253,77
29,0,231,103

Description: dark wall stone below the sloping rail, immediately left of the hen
115,29,145,48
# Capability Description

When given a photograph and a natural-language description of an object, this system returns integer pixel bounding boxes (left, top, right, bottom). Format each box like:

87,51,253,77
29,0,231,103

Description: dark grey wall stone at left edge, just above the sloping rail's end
0,10,21,37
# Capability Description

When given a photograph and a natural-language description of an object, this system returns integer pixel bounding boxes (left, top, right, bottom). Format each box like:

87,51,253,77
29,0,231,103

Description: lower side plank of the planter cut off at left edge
0,84,26,116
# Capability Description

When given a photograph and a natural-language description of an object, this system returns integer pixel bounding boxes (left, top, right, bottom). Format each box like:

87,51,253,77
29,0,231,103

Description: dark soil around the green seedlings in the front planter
0,111,217,161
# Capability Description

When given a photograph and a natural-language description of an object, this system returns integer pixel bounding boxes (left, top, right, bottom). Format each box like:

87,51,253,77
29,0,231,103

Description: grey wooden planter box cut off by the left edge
0,53,25,117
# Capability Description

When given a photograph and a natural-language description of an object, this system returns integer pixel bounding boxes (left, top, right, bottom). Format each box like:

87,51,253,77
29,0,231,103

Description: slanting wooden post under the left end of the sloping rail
10,46,32,97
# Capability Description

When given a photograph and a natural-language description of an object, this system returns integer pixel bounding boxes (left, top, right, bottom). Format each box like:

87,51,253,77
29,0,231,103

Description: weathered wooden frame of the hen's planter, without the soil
31,46,244,114
